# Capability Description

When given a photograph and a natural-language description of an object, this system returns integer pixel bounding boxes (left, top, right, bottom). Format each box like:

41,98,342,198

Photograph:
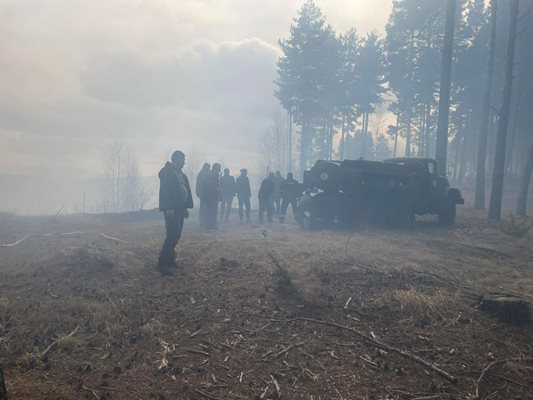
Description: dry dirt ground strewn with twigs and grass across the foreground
0,209,533,400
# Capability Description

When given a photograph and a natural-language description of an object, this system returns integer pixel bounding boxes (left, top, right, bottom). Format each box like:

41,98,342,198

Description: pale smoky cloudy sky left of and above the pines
0,0,392,178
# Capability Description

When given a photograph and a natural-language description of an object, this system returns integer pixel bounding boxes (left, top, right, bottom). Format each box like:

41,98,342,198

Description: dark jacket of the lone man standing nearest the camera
159,161,193,212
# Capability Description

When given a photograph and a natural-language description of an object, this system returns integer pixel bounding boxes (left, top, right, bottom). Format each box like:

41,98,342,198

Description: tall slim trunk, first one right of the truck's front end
474,0,498,210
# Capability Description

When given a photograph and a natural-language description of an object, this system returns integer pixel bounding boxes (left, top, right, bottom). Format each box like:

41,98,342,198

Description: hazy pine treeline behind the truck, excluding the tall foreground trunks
275,0,533,212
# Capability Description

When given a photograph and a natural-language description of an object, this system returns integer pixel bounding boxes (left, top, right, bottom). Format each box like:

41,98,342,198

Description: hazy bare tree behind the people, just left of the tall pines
259,109,289,172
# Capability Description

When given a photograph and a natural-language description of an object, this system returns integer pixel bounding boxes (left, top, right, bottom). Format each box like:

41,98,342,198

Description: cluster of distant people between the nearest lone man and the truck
192,163,300,229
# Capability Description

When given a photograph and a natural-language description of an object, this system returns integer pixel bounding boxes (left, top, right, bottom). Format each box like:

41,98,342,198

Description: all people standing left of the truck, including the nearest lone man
157,150,301,275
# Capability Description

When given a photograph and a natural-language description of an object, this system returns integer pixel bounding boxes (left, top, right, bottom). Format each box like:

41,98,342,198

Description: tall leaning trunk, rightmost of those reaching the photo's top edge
488,0,519,219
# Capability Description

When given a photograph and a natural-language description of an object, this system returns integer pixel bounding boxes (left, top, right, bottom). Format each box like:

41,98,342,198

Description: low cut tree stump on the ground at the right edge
480,294,531,325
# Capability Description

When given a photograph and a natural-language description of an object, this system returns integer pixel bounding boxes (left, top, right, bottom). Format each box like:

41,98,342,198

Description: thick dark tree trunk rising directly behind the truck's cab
436,0,457,175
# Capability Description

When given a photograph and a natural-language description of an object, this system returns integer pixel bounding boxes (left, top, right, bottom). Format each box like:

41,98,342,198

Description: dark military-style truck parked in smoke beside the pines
300,158,464,229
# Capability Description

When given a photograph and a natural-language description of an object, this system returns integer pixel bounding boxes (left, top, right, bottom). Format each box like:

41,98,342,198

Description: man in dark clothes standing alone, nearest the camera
157,150,193,275
